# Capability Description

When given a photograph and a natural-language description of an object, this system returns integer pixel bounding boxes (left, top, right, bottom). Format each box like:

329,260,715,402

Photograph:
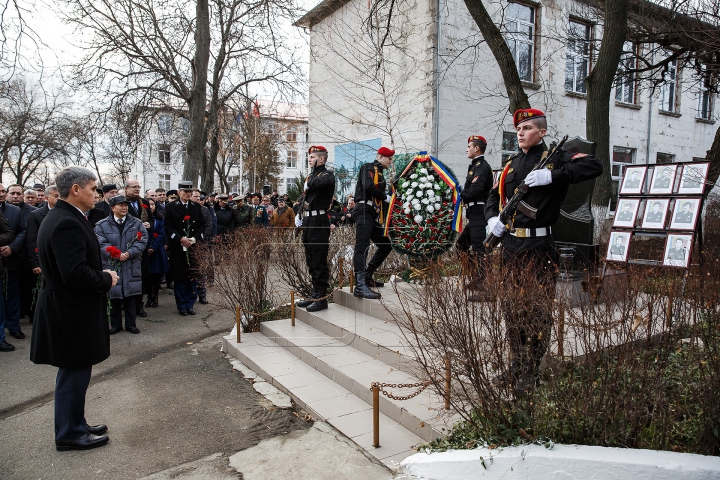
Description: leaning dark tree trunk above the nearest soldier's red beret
465,0,530,114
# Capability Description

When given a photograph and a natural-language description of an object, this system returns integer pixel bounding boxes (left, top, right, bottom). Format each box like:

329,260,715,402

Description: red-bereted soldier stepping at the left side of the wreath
353,147,395,299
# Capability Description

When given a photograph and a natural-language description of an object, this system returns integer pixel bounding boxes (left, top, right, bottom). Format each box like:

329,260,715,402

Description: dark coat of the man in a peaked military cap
165,201,206,282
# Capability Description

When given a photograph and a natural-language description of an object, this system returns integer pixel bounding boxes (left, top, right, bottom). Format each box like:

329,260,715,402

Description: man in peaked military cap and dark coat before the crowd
165,181,205,316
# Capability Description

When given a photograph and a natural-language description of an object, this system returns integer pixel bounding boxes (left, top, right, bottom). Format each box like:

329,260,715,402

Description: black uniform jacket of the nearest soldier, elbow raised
485,143,603,228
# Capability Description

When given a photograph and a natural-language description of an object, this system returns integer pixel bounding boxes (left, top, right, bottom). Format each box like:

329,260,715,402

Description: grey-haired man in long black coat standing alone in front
30,167,118,451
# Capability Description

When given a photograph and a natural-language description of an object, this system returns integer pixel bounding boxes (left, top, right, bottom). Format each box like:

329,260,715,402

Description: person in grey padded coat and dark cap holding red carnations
95,195,148,335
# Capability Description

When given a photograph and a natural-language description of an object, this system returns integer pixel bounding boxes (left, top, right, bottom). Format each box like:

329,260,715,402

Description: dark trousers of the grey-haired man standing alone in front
55,366,92,441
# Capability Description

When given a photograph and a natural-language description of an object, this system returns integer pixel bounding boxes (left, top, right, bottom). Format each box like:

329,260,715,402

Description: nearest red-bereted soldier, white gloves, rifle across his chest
485,108,603,390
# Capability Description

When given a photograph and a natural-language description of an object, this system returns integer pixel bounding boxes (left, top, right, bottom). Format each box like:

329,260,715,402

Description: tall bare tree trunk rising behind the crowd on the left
183,0,212,184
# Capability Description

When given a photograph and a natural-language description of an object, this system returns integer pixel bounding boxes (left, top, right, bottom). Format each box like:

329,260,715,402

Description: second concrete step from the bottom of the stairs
260,316,457,441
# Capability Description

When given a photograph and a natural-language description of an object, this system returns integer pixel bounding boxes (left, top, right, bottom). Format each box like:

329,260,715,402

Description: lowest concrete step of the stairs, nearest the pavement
223,332,424,470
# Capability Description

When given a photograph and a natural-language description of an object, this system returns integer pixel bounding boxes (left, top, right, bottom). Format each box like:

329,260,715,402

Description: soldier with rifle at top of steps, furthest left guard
295,146,335,312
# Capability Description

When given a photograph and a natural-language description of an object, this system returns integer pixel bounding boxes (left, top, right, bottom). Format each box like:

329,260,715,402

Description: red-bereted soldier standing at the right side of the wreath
455,135,493,302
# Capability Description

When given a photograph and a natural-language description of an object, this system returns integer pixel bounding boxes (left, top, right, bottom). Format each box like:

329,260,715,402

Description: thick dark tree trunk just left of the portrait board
585,0,628,207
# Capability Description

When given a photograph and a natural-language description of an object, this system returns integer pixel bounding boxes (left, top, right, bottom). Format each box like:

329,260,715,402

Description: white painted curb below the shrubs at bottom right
401,444,720,480
